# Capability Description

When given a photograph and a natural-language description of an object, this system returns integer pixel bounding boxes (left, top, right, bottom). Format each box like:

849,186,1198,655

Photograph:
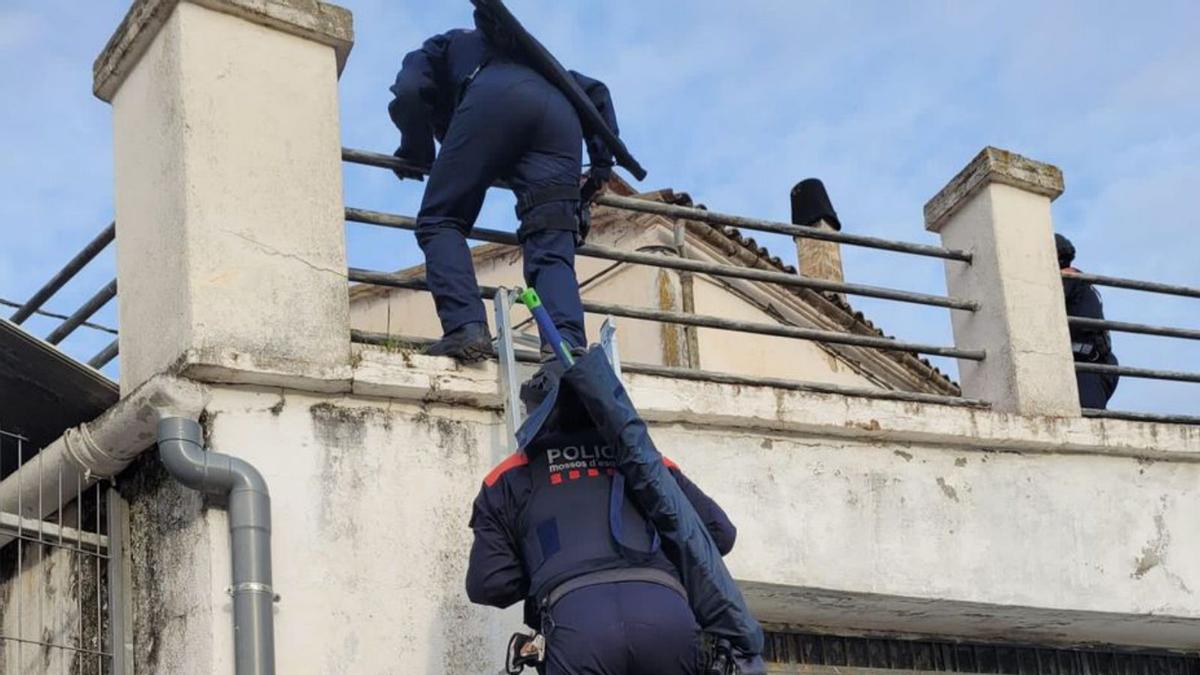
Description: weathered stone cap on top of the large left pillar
92,0,354,102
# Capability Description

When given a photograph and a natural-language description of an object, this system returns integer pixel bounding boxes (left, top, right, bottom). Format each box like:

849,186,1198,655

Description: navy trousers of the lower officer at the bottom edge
542,581,701,675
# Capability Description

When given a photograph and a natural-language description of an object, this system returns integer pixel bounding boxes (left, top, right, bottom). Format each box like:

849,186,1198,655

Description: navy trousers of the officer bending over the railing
416,61,587,347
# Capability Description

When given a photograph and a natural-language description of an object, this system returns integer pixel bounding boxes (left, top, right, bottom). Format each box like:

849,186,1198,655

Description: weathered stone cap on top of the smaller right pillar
925,145,1063,232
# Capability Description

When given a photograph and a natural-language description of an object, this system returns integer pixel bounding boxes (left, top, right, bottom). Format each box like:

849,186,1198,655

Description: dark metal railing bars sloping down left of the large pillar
0,222,119,369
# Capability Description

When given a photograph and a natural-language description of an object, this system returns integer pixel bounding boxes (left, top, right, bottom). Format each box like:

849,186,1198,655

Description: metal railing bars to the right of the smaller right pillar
1064,267,1200,424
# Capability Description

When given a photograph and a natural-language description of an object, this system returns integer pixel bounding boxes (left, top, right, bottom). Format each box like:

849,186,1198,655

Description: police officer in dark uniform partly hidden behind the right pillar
1054,234,1120,410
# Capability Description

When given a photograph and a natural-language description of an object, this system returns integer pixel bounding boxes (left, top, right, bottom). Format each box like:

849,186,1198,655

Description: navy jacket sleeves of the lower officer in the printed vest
467,453,737,612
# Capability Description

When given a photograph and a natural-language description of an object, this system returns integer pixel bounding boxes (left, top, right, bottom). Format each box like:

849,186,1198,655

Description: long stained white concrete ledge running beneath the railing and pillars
173,347,1200,462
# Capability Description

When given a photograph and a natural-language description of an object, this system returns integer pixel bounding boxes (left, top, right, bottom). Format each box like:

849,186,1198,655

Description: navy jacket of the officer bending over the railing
388,29,619,167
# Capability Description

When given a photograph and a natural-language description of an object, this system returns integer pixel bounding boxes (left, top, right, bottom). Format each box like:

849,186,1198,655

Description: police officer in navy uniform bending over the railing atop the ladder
388,11,617,362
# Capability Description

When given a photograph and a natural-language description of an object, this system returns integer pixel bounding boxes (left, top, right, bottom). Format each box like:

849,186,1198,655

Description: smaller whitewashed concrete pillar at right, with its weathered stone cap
925,148,1080,417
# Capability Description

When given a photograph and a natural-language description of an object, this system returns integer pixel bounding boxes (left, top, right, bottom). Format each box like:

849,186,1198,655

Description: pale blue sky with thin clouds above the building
0,0,1200,414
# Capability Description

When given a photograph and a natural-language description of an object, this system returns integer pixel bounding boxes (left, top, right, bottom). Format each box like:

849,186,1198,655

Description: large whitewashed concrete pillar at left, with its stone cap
95,0,353,392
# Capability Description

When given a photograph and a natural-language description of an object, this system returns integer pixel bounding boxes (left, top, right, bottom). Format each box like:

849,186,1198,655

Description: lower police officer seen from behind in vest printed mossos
467,364,737,675
